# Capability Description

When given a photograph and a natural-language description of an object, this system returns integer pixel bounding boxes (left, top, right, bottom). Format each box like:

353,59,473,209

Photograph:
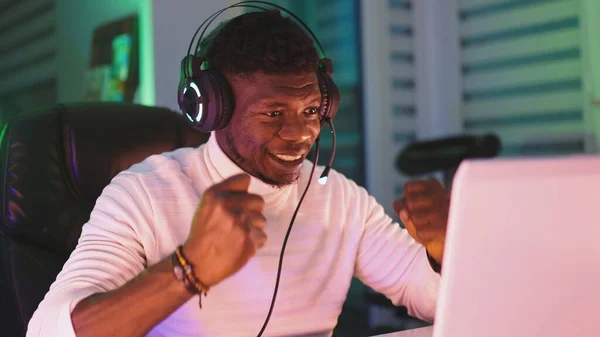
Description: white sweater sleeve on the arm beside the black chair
26,173,153,337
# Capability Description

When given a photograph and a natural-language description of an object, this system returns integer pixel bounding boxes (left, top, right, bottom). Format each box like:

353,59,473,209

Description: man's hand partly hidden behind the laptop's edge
394,180,450,265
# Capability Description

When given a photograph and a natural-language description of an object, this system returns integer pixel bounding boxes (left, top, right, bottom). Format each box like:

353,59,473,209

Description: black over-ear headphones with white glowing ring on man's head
177,1,340,132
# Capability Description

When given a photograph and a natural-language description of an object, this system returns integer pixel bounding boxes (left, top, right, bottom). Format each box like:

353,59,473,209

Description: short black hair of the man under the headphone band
201,10,319,74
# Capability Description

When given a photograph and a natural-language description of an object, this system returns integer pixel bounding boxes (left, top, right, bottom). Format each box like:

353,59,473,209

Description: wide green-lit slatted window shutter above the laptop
460,0,589,156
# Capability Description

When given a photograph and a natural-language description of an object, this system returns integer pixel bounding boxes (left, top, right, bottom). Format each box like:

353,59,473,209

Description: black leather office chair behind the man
0,103,209,337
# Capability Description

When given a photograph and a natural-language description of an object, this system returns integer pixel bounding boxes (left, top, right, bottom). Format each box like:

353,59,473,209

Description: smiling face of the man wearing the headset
215,72,321,186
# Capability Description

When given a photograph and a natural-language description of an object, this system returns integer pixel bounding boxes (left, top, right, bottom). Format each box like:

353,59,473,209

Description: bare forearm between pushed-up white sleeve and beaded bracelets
71,258,192,337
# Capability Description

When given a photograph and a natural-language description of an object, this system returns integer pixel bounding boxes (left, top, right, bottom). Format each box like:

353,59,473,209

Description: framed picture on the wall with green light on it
84,15,139,103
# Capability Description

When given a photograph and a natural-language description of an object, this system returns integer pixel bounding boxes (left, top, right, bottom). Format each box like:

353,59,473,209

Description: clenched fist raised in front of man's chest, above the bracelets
183,174,267,287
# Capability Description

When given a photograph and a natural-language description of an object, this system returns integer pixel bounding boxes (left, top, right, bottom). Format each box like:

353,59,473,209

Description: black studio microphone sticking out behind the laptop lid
396,134,502,176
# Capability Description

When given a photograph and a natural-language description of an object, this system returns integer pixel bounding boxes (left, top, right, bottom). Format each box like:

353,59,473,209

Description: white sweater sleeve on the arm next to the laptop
355,185,441,322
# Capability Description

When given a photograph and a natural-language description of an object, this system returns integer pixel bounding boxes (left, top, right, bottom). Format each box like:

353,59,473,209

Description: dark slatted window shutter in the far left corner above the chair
0,0,57,122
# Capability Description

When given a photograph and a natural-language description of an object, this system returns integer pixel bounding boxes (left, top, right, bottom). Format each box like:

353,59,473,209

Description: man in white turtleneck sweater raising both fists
28,12,448,337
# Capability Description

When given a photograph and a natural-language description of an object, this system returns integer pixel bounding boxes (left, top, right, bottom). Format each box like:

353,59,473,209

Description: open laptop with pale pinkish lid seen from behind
376,156,600,337
